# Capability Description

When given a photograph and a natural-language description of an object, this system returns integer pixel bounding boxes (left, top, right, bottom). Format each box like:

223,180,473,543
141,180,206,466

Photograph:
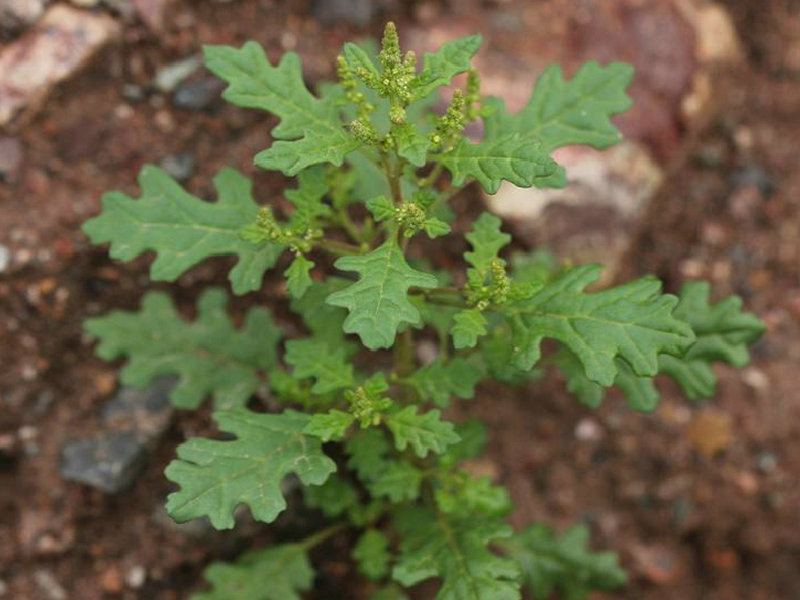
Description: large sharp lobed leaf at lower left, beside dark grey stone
165,409,336,529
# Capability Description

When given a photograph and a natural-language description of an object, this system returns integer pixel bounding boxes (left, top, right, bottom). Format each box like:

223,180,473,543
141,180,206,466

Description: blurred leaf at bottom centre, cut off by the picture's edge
392,506,520,600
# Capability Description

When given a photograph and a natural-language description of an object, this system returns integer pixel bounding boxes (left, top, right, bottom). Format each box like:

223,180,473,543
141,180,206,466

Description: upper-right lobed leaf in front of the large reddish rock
487,61,633,152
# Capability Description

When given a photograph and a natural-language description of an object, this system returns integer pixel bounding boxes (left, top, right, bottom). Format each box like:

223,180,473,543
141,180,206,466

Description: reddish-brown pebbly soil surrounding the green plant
0,0,800,600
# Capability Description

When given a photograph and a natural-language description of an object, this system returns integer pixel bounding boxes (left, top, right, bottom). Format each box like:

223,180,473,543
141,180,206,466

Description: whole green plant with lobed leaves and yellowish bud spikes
84,23,762,600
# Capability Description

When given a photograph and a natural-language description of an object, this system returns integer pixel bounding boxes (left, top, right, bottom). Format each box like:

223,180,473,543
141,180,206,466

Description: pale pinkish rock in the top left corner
0,4,119,126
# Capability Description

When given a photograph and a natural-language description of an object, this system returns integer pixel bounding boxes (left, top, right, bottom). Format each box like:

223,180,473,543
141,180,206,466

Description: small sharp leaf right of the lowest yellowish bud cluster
386,405,461,458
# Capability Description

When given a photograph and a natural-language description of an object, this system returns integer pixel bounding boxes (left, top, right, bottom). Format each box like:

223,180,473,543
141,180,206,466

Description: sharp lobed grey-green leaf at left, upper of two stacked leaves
83,165,284,294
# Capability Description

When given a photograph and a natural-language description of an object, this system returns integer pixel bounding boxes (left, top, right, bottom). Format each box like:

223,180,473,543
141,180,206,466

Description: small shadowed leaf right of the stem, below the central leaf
405,358,485,408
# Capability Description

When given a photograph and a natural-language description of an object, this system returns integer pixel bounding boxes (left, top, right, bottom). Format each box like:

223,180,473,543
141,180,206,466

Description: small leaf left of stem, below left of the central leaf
284,338,356,394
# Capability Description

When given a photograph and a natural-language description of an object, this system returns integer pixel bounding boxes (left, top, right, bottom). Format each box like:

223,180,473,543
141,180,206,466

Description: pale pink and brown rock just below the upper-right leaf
487,142,663,279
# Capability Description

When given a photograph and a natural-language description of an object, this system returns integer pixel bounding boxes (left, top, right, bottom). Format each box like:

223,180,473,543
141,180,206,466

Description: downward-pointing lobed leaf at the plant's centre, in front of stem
327,239,436,350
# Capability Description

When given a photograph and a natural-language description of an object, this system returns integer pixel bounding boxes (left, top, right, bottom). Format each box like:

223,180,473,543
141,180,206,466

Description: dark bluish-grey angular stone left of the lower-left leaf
60,431,146,494
